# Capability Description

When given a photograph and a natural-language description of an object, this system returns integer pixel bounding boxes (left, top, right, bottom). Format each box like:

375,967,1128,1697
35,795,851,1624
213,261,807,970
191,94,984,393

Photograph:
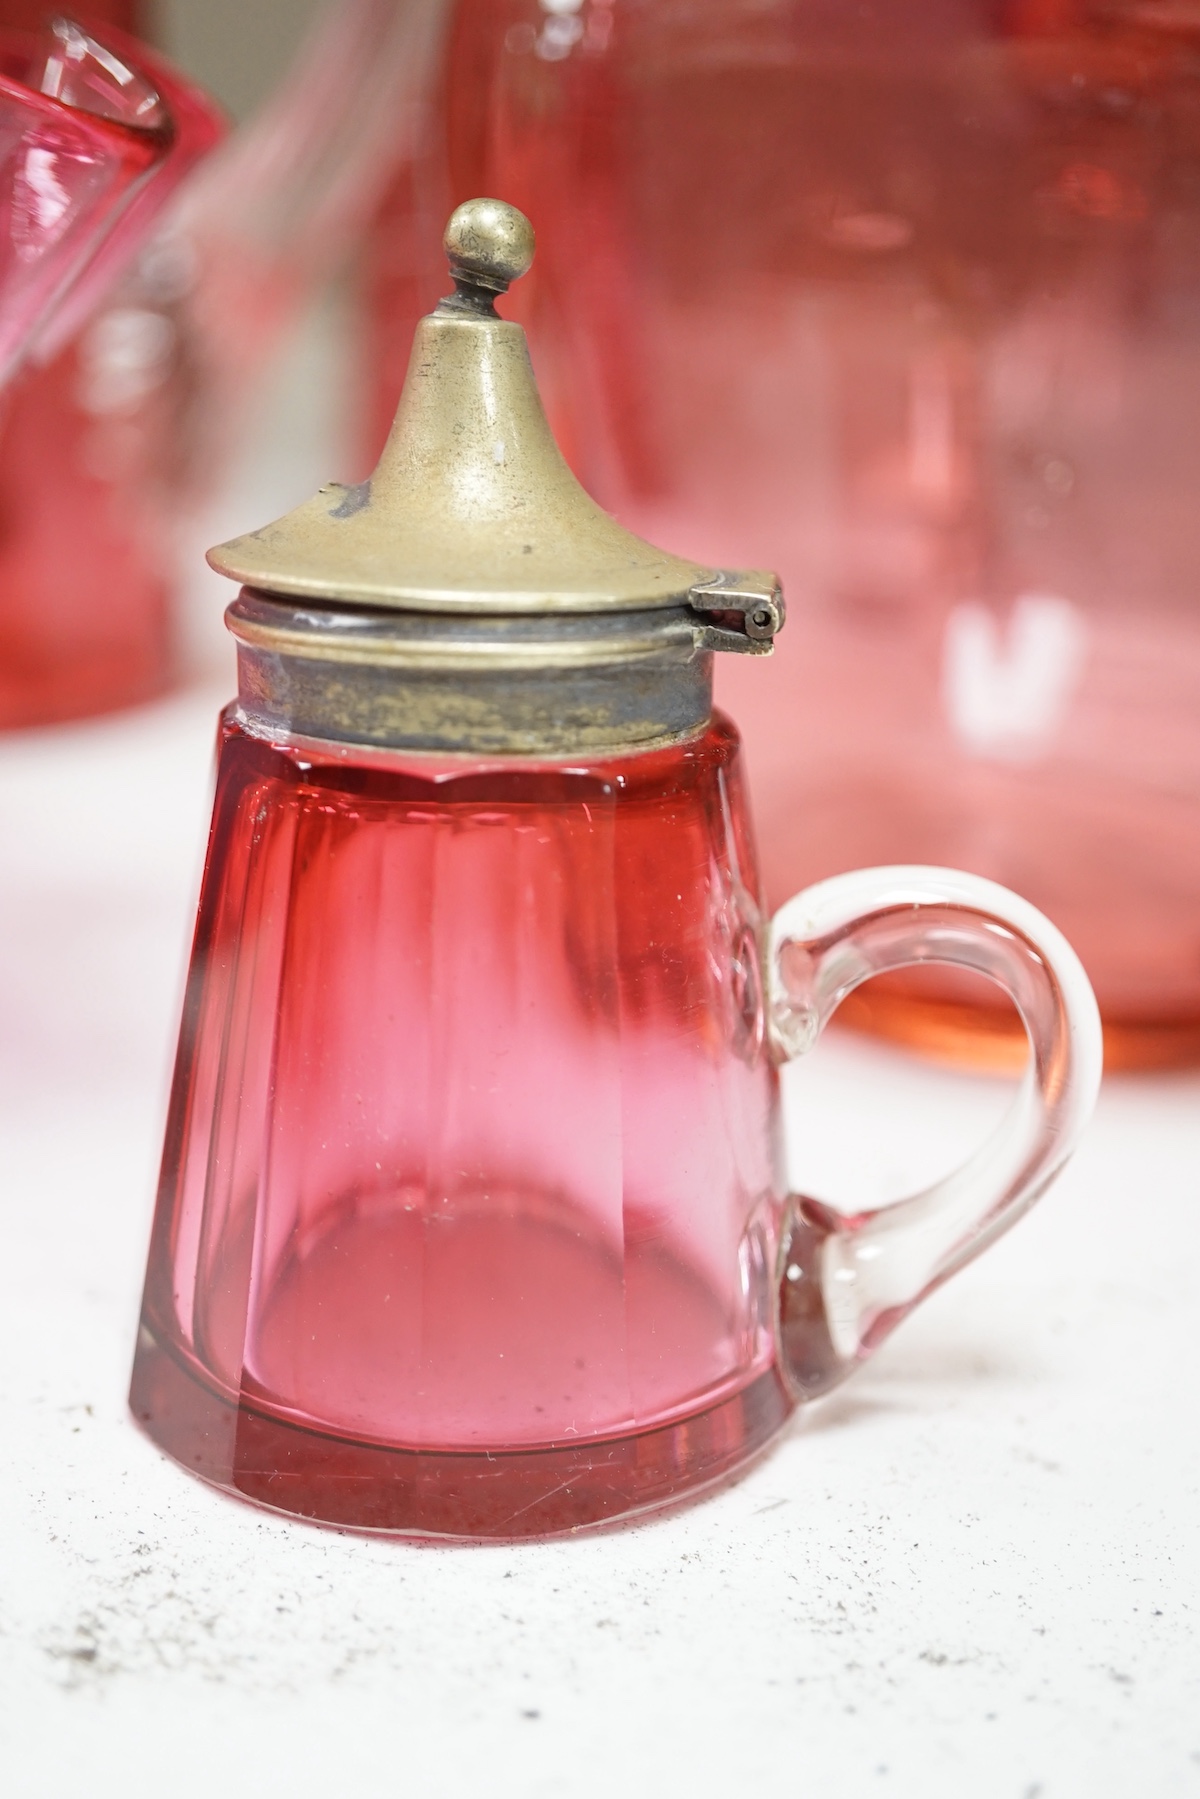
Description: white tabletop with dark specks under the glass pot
0,693,1200,1799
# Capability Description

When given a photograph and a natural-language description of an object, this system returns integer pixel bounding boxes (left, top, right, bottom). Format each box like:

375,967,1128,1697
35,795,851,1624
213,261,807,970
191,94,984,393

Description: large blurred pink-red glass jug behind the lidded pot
408,0,1200,1063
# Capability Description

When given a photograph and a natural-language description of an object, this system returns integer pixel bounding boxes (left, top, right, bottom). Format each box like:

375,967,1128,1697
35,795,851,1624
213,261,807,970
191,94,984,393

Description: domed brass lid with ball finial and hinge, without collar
209,200,783,649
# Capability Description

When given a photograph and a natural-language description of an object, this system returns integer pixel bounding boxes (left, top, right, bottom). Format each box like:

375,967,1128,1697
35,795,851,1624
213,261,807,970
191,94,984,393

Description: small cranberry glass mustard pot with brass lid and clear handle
131,200,1099,1538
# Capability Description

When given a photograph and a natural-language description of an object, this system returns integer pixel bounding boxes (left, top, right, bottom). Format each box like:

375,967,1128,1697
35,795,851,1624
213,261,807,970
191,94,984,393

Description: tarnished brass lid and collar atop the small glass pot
209,200,783,756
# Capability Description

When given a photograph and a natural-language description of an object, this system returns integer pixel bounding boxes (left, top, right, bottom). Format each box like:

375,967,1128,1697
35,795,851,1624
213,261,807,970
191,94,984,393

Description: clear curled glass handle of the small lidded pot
766,867,1101,1400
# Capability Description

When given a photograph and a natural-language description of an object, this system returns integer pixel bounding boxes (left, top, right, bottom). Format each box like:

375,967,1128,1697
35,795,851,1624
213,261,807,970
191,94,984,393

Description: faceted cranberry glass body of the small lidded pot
133,714,790,1536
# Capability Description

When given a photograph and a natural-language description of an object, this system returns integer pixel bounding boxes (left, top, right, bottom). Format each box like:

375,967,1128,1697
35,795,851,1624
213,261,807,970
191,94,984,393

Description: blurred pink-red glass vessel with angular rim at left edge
0,7,221,725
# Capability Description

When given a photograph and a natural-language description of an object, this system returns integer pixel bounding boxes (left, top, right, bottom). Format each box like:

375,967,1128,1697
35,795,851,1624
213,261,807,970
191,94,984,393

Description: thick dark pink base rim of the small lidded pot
130,1324,792,1542
